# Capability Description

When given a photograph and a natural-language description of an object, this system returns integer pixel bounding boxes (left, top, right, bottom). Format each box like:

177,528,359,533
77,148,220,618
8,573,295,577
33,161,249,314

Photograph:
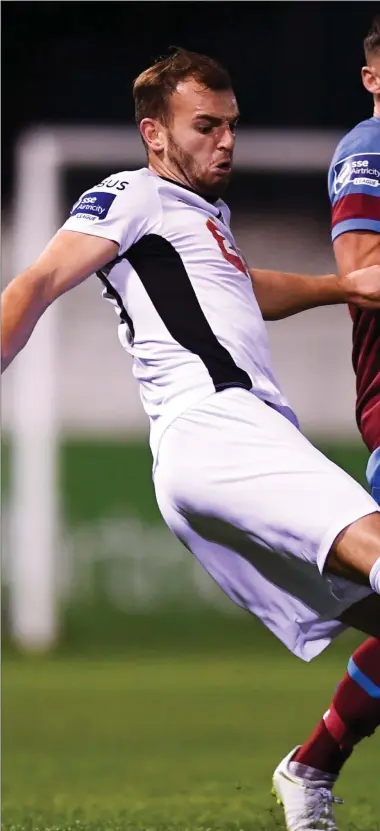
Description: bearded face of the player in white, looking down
164,79,239,197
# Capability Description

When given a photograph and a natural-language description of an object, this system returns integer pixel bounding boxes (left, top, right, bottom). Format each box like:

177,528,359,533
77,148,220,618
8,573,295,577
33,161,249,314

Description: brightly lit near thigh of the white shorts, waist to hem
155,390,376,572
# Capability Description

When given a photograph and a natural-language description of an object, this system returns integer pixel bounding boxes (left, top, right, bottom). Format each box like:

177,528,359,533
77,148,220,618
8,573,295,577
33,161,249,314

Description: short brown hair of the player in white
133,47,232,124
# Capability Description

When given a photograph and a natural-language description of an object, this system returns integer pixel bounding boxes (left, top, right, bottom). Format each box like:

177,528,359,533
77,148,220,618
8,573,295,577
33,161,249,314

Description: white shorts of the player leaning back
154,388,378,661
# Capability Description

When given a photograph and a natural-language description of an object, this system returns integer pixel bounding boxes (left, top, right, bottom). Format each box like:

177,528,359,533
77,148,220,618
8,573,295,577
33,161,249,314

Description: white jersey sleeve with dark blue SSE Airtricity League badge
62,174,158,256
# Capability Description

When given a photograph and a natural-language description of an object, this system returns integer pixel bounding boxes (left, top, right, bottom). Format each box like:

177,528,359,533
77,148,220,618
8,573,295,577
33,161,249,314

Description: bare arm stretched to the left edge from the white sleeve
1,231,119,372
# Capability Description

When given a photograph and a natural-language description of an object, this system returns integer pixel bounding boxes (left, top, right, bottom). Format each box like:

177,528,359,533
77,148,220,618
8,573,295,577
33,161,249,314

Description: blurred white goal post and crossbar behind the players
10,126,340,650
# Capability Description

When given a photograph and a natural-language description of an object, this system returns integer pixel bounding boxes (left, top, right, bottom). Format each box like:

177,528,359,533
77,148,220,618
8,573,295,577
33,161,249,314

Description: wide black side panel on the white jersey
124,234,252,390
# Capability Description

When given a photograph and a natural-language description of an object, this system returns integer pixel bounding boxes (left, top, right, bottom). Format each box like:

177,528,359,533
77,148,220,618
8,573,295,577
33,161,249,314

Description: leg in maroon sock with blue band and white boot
274,450,380,829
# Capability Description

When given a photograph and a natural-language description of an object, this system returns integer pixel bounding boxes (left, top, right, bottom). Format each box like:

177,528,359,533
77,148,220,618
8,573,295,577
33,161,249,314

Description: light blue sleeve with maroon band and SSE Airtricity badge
329,152,380,241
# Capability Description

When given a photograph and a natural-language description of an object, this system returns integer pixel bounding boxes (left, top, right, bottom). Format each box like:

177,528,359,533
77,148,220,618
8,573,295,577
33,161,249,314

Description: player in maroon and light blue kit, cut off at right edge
274,15,380,831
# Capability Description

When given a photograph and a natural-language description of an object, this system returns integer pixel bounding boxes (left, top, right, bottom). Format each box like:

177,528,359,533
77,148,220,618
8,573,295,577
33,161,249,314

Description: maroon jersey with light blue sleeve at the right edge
328,117,380,452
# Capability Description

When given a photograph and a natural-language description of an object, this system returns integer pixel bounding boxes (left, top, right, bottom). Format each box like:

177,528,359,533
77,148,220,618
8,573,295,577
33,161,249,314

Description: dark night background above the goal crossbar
2,0,380,204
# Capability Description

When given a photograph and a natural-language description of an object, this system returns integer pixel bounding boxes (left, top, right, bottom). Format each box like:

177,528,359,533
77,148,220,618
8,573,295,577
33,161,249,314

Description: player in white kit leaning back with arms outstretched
2,50,380,831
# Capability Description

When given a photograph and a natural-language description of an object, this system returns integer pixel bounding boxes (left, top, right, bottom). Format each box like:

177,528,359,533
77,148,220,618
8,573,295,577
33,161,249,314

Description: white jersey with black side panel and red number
63,168,295,457
